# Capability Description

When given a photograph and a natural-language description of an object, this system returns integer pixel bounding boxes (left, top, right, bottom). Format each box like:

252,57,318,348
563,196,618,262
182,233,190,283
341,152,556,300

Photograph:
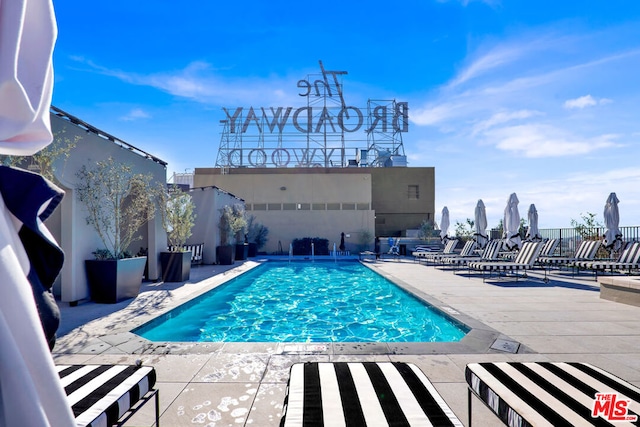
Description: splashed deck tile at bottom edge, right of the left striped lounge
160,383,259,426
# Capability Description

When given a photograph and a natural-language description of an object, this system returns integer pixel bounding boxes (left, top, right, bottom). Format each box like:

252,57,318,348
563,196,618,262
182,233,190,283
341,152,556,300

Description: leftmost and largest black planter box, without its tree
84,257,147,304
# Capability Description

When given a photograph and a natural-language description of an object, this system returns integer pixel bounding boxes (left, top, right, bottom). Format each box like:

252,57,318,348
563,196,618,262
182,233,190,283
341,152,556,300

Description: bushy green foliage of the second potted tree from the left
158,185,196,251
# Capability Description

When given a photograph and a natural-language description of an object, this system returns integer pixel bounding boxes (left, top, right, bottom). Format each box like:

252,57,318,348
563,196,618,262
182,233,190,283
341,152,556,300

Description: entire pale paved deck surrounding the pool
53,258,640,427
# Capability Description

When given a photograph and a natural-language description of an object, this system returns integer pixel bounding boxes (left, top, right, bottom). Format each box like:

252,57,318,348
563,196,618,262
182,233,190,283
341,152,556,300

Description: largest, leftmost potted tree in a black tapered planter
76,158,155,303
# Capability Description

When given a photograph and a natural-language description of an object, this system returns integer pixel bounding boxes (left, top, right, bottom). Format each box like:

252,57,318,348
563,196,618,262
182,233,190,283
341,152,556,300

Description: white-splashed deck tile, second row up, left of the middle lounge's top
192,353,270,383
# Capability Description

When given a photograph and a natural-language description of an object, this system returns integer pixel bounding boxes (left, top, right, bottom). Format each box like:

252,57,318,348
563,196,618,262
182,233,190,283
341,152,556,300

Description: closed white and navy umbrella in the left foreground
0,0,75,427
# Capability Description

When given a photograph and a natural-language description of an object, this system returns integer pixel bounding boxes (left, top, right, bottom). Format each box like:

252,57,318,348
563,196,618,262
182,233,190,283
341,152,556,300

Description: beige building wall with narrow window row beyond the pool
194,168,375,253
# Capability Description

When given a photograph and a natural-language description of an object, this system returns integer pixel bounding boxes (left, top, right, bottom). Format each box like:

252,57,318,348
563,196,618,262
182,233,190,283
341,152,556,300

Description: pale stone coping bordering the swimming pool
53,258,532,355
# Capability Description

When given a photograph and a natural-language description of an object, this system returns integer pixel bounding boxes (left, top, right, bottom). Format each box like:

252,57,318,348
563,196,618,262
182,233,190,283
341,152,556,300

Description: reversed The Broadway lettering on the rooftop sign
221,61,409,134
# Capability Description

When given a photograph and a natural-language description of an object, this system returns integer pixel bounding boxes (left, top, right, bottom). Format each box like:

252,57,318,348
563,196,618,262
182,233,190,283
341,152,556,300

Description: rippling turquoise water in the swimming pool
133,262,468,342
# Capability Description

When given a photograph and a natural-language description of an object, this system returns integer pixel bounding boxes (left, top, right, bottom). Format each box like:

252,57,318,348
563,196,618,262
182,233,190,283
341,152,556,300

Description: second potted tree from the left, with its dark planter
159,185,196,282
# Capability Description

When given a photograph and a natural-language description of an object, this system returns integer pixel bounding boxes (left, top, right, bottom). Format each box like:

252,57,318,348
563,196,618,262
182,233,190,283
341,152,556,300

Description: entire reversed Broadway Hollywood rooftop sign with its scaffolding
216,61,409,167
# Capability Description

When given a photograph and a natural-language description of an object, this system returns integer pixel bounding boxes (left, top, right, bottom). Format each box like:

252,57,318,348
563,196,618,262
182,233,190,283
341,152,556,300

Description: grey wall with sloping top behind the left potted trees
47,114,167,302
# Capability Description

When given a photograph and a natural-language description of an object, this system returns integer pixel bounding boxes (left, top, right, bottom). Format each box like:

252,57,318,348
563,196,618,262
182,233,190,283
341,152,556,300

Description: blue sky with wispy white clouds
53,0,640,228
